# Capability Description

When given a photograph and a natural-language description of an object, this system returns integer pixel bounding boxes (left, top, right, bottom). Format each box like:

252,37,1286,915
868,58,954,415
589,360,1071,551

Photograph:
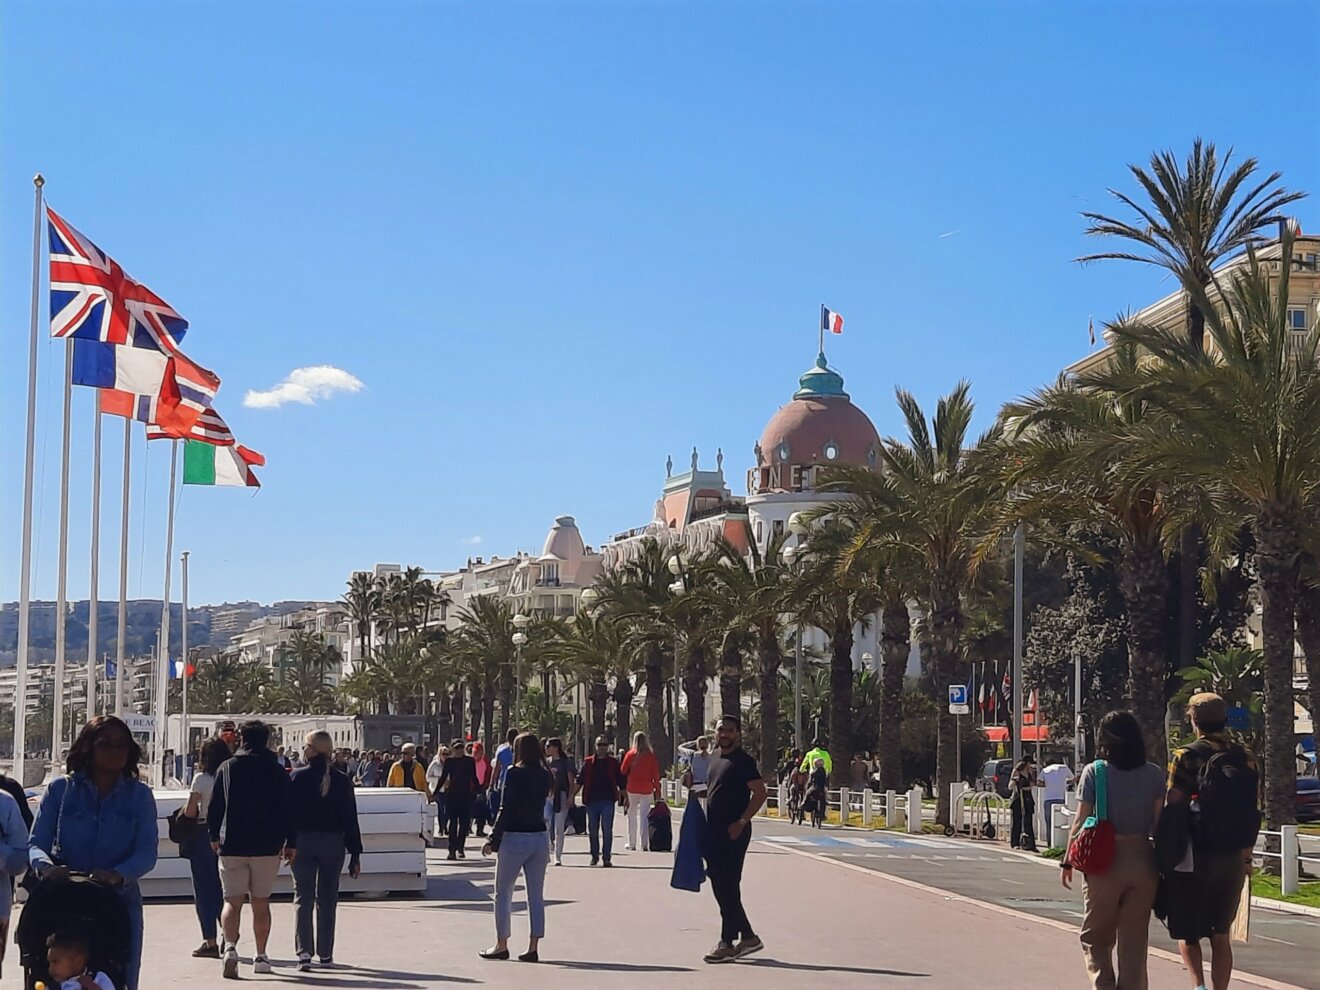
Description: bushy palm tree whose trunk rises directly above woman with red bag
1002,342,1185,759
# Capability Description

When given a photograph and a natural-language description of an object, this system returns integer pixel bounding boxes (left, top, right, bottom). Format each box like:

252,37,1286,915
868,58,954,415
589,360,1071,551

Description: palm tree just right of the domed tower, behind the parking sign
822,381,1002,825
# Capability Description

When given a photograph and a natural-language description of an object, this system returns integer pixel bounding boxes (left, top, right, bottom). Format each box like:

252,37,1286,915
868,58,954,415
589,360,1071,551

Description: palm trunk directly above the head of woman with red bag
1118,543,1172,766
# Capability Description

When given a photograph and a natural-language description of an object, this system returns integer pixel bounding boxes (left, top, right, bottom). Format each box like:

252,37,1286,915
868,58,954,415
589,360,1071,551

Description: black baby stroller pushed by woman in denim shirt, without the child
15,873,131,990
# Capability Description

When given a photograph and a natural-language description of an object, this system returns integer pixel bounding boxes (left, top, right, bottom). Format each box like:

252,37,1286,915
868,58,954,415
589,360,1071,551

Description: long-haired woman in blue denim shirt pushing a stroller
30,715,158,990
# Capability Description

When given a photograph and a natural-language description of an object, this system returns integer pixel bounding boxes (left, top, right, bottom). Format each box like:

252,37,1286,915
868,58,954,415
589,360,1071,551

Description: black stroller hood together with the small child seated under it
15,873,132,990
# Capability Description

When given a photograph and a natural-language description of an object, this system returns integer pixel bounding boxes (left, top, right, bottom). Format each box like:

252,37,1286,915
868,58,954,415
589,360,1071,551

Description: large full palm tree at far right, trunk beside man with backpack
1094,232,1320,828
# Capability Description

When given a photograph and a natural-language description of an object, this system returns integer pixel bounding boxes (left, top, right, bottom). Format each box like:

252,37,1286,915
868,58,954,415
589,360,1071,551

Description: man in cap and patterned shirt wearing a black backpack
1164,693,1261,990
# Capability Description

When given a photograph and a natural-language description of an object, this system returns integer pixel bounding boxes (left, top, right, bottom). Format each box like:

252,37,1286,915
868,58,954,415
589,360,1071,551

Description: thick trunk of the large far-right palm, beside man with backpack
1255,510,1302,839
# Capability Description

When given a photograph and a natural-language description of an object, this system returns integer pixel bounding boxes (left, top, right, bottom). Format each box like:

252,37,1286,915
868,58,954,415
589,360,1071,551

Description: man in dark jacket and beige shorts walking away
206,721,294,979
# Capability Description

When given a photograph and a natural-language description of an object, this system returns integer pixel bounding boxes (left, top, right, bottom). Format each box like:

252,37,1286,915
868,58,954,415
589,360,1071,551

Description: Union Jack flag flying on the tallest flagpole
46,207,187,354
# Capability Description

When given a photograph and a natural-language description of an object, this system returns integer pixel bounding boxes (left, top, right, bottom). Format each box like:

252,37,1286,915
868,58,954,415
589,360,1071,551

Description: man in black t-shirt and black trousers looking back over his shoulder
705,715,766,962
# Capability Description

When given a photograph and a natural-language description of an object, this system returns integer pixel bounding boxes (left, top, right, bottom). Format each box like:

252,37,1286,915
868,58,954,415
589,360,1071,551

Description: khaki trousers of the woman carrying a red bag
1081,836,1159,990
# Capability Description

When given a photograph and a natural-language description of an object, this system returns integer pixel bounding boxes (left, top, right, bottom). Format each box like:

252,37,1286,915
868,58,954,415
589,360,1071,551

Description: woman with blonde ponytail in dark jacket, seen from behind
288,733,362,972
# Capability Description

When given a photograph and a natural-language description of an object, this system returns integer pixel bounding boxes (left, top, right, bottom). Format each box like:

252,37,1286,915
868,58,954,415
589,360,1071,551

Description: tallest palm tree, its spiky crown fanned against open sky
1078,137,1305,681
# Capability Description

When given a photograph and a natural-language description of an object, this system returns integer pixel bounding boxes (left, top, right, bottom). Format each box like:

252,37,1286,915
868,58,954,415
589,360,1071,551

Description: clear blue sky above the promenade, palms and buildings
0,0,1320,602
